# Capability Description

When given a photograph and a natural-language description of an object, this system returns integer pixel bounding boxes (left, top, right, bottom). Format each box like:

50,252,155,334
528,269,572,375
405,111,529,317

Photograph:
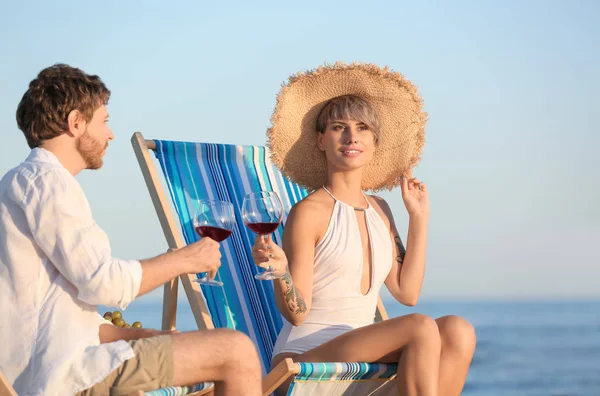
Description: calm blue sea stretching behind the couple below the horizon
100,293,600,396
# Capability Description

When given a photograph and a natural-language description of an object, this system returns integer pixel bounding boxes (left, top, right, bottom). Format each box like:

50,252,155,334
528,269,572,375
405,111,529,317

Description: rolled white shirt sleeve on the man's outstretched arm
22,169,142,309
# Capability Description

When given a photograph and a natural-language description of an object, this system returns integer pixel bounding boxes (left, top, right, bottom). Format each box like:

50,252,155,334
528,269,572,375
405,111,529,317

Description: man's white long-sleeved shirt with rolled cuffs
0,148,142,395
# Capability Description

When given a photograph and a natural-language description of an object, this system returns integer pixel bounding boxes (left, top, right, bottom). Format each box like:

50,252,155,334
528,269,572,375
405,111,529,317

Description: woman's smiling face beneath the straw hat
317,119,375,171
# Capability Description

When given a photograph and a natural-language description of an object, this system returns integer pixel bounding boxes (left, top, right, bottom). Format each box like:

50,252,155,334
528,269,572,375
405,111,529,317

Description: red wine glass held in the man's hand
194,199,235,286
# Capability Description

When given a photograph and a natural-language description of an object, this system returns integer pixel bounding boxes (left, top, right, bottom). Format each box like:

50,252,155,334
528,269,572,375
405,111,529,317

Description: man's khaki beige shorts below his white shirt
77,335,173,396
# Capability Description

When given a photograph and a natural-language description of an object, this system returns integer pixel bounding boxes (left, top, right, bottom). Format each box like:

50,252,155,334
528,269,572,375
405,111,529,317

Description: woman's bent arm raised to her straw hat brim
376,175,429,306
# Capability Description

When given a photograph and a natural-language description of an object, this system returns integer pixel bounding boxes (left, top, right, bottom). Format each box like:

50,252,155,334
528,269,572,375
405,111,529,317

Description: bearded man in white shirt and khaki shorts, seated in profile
0,64,260,396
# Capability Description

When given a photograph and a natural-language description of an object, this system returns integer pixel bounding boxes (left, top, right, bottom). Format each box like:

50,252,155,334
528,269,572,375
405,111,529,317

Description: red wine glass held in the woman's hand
242,191,283,280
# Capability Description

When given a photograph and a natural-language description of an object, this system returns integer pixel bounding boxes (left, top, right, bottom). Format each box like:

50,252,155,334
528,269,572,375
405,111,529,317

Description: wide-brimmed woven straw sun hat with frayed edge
267,62,427,191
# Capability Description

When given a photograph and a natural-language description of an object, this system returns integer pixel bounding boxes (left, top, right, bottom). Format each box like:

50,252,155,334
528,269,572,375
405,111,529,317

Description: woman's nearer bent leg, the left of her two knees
294,314,441,396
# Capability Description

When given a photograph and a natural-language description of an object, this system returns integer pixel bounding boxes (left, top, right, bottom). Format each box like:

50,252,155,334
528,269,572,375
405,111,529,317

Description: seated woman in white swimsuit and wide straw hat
253,63,475,395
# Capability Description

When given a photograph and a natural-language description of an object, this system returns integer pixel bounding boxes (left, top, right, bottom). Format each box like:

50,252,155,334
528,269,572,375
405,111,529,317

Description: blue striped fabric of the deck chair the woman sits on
149,140,396,395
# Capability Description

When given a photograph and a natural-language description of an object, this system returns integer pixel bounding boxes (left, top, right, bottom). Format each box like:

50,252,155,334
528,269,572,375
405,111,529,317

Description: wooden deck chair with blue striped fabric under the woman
132,132,397,395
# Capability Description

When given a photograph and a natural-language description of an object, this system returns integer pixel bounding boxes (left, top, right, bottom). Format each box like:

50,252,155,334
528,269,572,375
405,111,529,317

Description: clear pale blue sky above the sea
0,0,600,300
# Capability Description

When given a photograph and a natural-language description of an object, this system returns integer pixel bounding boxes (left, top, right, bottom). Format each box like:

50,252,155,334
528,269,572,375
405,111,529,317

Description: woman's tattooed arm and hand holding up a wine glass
253,200,318,326
